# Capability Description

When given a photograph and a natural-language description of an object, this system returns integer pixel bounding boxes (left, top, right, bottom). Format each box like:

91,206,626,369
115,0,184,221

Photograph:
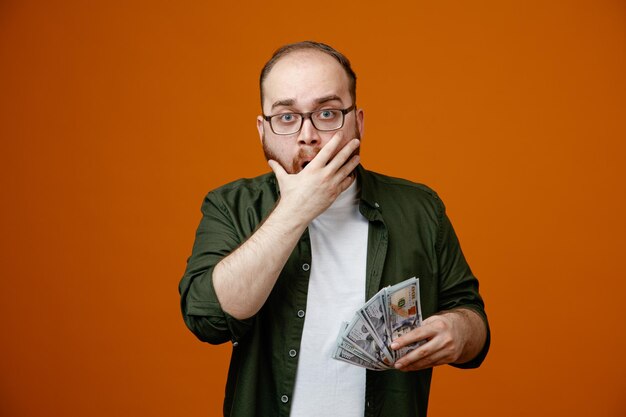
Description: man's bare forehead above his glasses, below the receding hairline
263,50,350,111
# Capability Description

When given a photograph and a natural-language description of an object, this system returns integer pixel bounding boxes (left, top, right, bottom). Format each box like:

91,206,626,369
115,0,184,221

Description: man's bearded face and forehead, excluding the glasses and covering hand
257,49,363,174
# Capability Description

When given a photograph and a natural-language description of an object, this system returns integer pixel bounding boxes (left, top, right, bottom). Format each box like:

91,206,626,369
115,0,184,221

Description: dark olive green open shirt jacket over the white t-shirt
179,166,489,417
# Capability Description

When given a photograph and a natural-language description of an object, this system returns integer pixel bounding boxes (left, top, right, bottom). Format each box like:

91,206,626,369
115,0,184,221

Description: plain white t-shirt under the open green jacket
291,181,368,417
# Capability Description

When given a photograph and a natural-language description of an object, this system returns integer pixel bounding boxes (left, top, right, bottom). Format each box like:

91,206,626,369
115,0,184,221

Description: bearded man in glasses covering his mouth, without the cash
179,42,489,417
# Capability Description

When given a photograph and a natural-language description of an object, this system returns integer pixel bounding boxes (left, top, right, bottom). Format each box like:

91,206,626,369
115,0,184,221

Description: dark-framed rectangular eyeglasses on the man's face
263,104,356,135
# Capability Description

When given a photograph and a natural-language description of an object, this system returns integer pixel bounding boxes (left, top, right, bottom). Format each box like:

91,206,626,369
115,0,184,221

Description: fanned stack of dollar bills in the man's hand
333,278,422,371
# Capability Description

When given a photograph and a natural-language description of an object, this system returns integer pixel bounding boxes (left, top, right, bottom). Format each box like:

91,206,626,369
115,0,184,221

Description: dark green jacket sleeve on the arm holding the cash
436,198,491,368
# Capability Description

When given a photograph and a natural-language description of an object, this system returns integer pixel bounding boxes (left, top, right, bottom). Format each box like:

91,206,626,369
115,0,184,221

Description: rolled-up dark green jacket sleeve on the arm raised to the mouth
178,193,254,344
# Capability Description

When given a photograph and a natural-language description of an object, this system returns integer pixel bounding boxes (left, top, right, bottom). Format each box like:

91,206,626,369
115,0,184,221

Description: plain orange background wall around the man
0,0,626,417
